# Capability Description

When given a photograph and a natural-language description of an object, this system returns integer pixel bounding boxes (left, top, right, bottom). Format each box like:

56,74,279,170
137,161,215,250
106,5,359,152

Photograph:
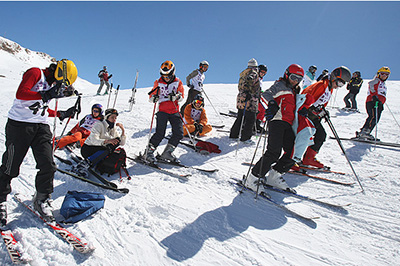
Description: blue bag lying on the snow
60,191,105,223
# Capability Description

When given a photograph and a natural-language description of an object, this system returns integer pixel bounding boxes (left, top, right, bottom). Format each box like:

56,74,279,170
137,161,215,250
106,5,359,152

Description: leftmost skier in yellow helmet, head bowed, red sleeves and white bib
0,59,78,225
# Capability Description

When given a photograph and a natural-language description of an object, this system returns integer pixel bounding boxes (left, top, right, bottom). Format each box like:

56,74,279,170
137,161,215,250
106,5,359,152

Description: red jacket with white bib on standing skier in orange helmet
150,77,184,114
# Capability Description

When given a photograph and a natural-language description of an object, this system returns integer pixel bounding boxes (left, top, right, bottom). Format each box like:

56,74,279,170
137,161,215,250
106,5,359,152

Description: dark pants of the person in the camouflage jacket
229,109,256,141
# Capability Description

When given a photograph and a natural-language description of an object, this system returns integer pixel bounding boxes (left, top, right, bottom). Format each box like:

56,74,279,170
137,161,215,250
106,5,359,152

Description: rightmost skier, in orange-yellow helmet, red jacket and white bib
356,66,390,140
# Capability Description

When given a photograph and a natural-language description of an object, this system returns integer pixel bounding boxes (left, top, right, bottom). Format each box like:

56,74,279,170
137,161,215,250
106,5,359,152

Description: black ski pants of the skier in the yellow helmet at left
0,119,56,202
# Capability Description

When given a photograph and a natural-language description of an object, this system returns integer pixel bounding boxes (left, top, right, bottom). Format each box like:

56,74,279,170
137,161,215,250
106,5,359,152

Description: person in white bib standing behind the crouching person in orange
181,60,210,116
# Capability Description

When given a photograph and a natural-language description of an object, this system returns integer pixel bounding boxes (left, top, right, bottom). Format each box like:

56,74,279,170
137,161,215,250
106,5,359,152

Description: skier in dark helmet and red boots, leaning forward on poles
302,66,351,168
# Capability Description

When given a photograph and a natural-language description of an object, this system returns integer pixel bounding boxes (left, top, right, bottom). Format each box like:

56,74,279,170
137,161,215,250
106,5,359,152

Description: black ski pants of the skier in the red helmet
251,120,295,178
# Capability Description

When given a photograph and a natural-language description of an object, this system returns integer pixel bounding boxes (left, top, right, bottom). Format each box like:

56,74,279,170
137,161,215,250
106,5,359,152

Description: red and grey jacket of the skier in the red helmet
262,78,296,125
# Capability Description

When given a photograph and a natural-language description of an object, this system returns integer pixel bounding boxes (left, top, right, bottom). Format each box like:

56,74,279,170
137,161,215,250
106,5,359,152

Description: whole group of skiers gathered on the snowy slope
0,58,390,225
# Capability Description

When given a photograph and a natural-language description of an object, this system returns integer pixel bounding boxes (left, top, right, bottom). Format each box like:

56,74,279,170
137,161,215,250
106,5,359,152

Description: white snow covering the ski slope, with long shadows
0,35,400,266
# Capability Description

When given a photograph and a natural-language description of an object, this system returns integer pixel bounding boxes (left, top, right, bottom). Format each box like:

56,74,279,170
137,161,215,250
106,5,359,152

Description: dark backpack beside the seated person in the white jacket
96,148,129,176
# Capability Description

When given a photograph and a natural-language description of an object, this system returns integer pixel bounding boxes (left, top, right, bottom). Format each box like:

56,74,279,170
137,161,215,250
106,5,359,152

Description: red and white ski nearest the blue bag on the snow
14,195,95,253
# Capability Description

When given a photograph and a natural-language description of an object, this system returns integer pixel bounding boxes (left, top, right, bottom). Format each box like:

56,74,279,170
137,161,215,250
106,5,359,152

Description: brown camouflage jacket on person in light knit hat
236,67,261,113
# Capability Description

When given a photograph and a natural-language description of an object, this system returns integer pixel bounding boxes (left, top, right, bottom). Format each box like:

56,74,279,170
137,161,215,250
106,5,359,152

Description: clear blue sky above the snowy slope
0,1,400,88
